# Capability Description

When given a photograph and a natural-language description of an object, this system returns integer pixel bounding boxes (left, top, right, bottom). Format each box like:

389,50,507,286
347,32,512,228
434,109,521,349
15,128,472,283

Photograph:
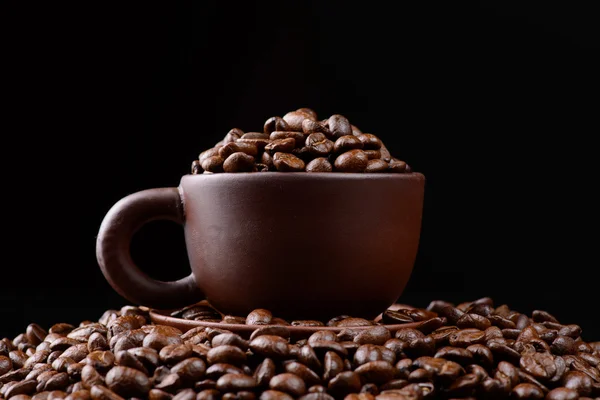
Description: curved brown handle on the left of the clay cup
96,188,204,309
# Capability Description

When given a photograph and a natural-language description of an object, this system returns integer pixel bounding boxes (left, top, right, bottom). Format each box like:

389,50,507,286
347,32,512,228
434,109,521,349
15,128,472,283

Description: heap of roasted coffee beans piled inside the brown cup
192,108,411,174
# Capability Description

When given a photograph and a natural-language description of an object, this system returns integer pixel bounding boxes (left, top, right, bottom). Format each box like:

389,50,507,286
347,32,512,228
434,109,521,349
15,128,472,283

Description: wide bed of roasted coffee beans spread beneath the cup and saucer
0,298,600,400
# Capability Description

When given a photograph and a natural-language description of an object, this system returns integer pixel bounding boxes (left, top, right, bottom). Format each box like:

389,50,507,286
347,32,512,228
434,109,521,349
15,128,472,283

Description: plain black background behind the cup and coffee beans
0,1,600,340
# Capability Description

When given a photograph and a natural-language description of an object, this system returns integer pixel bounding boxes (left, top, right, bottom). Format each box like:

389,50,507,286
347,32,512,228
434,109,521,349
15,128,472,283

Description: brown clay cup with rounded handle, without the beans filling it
96,172,425,320
